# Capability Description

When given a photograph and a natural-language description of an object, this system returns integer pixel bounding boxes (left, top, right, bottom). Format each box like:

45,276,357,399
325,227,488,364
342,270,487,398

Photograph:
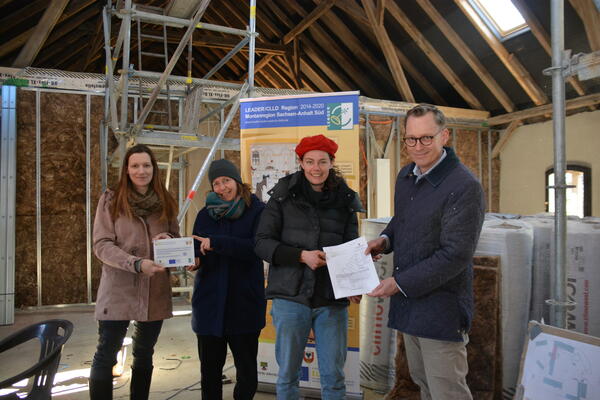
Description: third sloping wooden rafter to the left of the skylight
388,2,483,110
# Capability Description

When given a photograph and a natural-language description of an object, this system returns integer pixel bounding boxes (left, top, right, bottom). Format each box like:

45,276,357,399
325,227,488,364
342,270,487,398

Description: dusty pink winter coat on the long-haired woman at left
94,190,179,321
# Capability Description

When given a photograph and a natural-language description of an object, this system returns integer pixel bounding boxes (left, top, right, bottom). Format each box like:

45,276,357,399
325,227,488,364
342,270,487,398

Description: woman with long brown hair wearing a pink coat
90,145,179,400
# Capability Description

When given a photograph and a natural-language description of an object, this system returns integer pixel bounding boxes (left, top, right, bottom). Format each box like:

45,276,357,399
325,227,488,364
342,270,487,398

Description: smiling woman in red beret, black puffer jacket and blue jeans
255,135,362,400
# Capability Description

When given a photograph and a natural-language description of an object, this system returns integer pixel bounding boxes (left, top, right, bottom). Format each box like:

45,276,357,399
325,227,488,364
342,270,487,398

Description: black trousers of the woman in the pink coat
90,320,163,380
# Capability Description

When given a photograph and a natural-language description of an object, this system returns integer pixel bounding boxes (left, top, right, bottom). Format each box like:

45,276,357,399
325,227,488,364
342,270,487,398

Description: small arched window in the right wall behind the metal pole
546,164,592,217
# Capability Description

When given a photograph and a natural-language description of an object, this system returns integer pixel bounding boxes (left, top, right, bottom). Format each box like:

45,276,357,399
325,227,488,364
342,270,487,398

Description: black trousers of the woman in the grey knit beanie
197,332,260,400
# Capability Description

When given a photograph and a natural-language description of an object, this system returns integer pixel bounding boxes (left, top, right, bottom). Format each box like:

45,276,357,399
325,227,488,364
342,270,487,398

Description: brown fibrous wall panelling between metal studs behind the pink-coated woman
15,90,178,307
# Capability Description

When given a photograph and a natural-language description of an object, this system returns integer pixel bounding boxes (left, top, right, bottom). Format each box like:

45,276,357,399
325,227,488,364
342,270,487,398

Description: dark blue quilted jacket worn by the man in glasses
383,147,485,341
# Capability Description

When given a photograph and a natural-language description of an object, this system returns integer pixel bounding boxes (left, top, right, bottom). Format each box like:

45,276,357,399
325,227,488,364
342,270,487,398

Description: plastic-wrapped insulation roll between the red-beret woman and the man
360,218,395,391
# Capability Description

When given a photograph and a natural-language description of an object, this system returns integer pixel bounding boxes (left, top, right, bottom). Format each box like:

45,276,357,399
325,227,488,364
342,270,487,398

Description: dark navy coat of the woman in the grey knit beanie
192,195,266,337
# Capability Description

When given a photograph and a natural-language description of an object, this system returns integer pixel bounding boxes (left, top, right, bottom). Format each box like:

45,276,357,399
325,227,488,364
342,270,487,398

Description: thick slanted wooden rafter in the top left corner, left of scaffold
13,0,69,68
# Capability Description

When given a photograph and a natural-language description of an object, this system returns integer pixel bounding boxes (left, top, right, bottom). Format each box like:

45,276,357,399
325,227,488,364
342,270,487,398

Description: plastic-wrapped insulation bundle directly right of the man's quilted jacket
475,219,533,396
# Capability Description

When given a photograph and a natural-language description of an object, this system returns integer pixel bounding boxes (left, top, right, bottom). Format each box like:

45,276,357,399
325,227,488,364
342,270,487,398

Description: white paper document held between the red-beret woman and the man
323,236,379,299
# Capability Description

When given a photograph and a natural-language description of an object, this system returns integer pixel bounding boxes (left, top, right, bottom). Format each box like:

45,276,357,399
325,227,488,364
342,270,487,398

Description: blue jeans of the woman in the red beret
271,299,348,400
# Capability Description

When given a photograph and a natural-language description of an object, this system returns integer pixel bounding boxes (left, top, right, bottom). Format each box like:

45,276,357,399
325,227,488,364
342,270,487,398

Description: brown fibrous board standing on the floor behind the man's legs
385,257,502,400
